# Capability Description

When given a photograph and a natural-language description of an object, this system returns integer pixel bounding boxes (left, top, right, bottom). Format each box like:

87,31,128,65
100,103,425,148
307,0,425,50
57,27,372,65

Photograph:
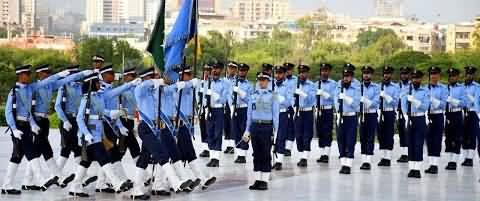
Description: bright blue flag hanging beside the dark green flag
165,0,197,81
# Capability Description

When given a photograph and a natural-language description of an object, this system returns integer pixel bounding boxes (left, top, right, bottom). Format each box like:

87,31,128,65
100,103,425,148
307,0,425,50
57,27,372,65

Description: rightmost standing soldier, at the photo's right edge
462,66,480,167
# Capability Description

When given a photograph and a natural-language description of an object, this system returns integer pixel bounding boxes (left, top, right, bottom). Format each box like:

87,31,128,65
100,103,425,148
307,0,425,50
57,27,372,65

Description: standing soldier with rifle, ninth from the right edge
315,63,337,163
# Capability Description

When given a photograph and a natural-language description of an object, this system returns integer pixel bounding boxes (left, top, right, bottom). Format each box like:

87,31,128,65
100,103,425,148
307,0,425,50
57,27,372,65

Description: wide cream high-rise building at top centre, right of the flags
232,0,289,22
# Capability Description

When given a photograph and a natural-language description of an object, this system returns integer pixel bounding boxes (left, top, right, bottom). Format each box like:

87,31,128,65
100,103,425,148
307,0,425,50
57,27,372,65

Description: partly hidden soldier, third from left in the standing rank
223,61,238,154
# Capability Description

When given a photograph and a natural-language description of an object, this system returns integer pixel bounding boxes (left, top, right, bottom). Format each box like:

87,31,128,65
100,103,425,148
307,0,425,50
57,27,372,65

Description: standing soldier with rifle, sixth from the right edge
378,66,403,166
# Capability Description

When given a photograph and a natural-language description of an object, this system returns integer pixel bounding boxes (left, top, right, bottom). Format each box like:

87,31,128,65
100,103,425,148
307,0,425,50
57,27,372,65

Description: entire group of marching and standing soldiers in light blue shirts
2,56,480,199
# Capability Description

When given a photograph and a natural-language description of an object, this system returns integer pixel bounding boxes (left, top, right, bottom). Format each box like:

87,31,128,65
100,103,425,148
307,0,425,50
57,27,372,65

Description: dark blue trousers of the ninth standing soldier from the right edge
316,109,333,148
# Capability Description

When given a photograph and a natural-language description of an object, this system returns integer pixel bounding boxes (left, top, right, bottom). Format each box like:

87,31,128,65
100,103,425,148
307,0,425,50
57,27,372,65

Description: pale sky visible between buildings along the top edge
49,0,480,23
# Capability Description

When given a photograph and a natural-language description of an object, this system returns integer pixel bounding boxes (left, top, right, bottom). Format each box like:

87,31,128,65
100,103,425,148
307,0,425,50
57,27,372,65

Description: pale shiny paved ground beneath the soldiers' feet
0,128,480,201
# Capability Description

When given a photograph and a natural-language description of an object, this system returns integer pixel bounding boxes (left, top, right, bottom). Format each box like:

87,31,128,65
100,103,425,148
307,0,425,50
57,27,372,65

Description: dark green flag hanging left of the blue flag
147,0,165,69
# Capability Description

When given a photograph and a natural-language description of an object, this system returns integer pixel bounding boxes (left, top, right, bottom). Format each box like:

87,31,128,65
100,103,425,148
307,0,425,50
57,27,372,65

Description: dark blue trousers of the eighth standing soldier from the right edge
337,116,358,158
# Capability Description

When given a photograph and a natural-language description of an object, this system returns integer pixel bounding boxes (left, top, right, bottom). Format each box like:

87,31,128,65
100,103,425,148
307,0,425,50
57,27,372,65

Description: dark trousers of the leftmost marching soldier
10,121,40,164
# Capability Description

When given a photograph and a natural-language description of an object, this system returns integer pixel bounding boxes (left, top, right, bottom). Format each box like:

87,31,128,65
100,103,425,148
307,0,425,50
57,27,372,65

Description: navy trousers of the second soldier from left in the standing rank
207,108,225,151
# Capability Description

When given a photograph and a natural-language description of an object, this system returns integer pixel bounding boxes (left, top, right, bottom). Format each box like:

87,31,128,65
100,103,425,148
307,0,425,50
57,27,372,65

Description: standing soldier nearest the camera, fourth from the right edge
401,69,430,178
